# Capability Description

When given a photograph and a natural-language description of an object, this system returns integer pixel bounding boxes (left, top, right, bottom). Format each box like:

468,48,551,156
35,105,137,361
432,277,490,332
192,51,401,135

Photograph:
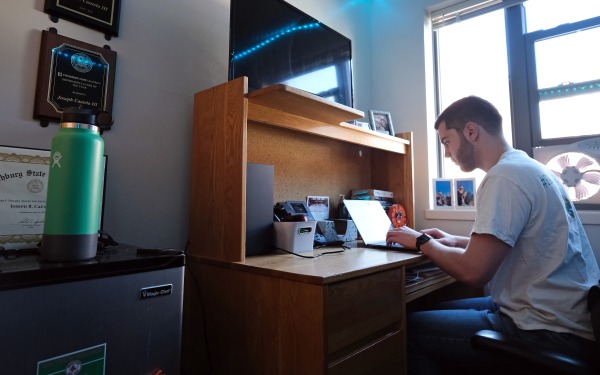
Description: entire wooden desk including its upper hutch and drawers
184,78,451,375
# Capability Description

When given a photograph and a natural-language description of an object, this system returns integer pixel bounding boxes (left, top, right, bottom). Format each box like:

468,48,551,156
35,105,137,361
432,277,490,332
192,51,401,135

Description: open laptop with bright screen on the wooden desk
344,199,417,251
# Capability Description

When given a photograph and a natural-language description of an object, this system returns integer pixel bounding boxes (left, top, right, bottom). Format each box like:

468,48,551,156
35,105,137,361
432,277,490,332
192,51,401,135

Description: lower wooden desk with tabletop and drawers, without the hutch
184,248,453,375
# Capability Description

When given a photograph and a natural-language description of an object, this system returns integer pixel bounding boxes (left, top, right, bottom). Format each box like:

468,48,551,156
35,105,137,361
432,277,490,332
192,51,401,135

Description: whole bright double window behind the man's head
432,0,600,182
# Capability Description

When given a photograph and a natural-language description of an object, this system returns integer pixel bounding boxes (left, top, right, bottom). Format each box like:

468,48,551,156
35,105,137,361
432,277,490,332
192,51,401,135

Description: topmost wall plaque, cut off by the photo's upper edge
44,0,121,36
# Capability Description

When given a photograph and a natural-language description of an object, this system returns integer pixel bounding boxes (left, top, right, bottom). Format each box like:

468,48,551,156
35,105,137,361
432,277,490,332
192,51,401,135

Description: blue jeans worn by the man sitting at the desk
406,297,597,375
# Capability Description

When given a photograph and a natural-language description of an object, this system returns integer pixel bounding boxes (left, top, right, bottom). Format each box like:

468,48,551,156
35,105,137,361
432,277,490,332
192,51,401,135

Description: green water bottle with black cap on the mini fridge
40,108,104,262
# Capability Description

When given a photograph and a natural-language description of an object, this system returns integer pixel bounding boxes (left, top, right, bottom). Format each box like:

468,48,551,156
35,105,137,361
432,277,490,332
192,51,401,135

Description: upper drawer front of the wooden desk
325,268,404,363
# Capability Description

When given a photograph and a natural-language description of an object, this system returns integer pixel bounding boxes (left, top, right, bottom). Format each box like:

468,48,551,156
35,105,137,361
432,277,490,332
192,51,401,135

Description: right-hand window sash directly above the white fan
525,10,600,147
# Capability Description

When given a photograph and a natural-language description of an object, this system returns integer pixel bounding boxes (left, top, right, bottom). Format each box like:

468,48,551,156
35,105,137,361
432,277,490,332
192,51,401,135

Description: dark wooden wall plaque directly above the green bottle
33,30,117,122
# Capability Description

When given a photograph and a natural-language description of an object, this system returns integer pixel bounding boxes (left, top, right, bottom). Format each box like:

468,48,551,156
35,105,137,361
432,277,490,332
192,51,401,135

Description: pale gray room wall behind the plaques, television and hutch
0,0,600,251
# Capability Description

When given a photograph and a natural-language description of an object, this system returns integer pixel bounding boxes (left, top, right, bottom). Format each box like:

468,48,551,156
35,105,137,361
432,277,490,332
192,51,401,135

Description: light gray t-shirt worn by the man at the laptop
472,150,600,340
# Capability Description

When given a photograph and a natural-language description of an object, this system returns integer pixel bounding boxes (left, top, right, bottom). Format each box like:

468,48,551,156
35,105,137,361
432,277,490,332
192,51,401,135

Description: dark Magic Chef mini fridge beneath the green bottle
0,245,185,375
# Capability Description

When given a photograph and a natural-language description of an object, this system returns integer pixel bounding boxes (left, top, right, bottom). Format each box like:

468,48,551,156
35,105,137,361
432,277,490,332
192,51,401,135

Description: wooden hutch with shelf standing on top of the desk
188,77,414,262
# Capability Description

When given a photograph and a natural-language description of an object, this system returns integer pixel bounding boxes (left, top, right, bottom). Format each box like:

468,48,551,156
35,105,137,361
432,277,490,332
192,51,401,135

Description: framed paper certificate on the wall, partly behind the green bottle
0,144,108,249
